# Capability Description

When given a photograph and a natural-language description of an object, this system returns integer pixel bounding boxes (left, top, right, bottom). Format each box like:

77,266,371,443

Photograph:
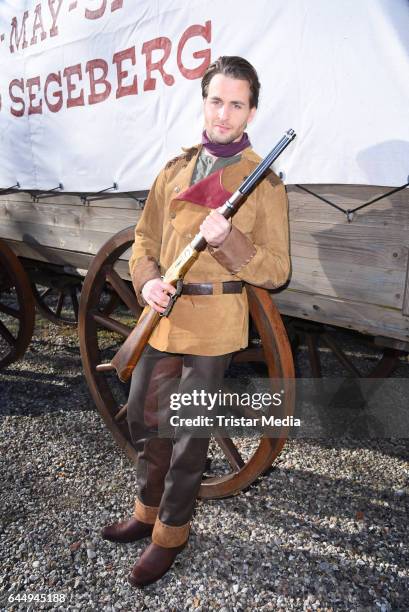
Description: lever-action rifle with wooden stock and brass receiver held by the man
97,130,295,382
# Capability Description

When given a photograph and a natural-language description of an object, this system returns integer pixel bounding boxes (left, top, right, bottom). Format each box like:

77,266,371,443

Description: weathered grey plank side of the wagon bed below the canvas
0,185,409,349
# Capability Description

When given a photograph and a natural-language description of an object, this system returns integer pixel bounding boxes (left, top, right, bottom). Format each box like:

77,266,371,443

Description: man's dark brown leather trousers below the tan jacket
128,345,231,527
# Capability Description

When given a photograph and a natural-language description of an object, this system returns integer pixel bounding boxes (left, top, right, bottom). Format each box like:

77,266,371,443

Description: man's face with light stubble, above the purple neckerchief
204,74,256,144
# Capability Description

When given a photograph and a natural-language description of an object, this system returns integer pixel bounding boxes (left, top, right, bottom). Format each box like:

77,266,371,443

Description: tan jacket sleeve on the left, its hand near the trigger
129,170,165,306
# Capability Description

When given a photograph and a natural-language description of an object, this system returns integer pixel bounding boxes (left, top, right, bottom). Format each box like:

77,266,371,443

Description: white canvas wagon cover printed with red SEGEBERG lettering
0,0,409,191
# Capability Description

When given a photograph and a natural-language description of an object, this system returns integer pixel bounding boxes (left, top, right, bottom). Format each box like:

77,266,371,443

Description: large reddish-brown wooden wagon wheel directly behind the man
79,227,294,498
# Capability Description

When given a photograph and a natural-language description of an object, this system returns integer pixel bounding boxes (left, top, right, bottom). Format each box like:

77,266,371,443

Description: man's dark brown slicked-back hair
202,55,260,108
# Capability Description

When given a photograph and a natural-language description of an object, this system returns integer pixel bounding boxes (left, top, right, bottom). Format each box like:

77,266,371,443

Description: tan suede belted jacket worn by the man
129,145,290,355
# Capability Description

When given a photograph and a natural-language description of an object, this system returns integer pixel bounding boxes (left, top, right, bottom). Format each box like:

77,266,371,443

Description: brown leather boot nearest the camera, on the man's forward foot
128,542,186,588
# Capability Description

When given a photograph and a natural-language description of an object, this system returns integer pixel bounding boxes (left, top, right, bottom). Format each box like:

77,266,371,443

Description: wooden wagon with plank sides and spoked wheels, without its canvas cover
0,179,409,497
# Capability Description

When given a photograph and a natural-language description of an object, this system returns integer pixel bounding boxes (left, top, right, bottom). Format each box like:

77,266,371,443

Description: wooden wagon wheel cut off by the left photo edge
0,240,35,367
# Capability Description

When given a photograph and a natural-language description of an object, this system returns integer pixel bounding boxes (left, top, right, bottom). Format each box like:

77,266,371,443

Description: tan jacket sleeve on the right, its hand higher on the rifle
208,180,291,289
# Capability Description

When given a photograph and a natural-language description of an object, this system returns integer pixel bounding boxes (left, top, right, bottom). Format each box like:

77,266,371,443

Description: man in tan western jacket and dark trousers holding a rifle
102,56,290,587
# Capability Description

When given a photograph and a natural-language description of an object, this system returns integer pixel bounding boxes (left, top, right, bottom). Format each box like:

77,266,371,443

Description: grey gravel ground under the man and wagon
0,319,409,612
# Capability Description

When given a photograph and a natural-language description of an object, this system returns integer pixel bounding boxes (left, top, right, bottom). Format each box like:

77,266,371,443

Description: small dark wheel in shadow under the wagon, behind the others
31,278,82,327
